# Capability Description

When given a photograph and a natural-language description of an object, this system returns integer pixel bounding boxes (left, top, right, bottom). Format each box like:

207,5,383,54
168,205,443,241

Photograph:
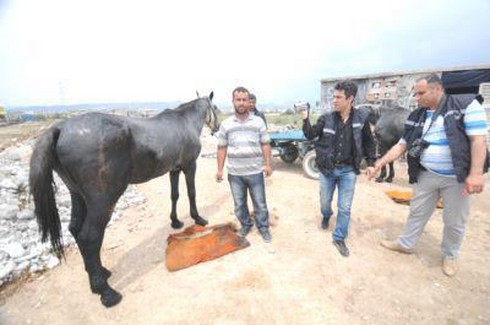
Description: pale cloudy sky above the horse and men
0,0,490,106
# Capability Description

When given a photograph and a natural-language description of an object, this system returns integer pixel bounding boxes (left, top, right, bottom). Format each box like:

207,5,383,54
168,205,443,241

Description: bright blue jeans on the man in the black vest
320,166,357,240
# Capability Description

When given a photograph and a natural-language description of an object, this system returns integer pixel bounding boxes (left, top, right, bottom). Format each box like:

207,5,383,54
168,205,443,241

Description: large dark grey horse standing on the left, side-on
29,93,219,307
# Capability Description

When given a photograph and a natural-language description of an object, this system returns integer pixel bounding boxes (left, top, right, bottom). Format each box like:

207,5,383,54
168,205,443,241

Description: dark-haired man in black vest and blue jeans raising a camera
301,81,376,257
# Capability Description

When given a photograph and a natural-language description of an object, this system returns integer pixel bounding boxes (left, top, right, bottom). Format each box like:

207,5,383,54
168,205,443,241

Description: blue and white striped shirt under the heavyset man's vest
402,100,487,177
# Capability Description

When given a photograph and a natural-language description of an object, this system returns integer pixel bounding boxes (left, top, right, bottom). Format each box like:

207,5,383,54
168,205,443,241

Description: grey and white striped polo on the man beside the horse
217,114,270,176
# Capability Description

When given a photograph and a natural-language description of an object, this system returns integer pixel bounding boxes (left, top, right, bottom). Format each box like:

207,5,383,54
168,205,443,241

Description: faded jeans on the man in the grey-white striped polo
228,173,269,230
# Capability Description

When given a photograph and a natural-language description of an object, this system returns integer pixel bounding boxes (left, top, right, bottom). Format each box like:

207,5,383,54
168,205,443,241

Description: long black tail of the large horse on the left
29,126,64,258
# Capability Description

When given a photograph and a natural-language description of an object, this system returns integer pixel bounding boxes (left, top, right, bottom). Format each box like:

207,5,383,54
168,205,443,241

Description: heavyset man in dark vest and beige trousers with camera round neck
367,74,488,276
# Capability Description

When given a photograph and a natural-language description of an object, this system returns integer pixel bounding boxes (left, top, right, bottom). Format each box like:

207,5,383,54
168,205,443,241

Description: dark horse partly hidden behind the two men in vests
361,105,410,183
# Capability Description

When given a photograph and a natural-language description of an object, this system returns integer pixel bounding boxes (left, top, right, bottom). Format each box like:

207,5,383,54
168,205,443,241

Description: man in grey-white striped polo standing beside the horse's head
216,87,272,242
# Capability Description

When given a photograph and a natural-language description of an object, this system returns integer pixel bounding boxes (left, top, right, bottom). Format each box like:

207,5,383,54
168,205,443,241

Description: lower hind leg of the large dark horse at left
77,202,122,307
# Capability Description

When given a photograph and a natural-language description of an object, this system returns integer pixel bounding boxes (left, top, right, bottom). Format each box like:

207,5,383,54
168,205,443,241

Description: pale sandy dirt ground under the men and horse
0,130,490,325
